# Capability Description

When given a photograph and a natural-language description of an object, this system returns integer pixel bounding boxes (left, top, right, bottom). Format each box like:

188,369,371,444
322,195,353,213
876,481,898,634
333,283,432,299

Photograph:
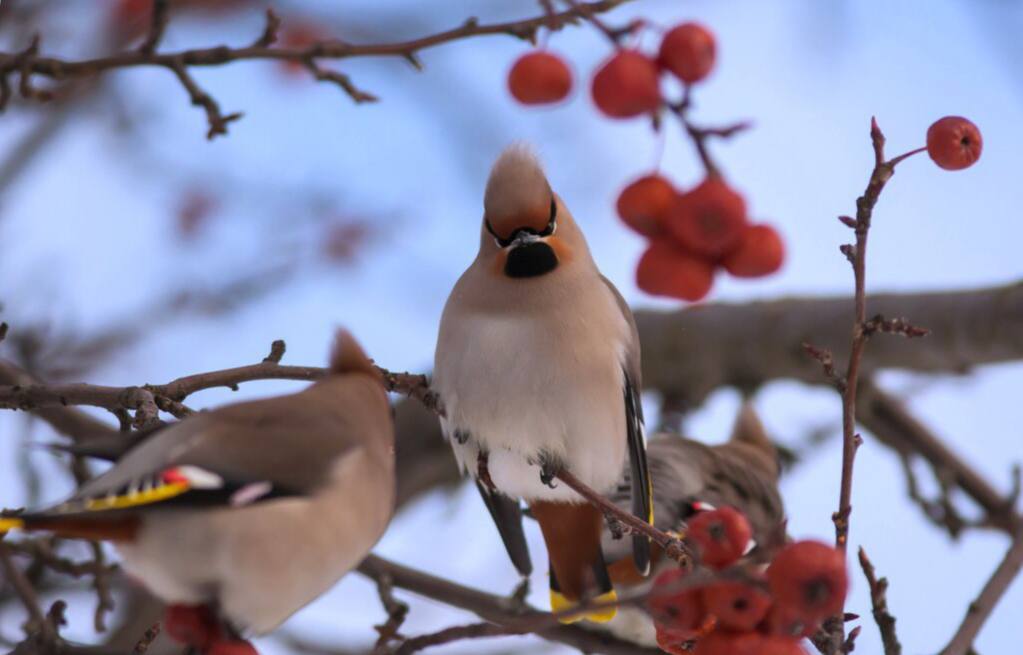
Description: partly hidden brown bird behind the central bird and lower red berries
604,403,785,646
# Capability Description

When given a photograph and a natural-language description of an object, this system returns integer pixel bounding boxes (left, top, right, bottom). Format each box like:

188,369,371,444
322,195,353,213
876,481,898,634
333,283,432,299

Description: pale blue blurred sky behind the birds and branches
0,0,1023,655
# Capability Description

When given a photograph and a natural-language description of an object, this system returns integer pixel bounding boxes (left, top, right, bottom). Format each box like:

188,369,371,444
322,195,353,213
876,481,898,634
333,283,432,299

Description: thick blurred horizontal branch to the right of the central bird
635,282,1023,408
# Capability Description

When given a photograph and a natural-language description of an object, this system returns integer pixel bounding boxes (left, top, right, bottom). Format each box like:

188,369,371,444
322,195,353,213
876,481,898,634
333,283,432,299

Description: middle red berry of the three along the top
591,50,661,119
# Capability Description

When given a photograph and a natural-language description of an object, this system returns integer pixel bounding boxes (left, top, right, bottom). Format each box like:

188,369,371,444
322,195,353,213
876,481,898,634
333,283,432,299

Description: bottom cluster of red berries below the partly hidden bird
647,508,849,655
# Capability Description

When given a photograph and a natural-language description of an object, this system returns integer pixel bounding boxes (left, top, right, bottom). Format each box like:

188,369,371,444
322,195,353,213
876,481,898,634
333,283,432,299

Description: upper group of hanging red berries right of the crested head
508,23,785,301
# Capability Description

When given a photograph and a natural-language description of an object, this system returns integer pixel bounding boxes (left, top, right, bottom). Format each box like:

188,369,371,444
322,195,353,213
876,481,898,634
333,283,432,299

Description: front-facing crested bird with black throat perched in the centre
433,145,653,621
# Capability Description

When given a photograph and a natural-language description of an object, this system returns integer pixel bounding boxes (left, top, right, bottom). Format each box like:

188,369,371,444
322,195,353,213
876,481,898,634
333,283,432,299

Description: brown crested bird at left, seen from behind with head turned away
0,331,395,653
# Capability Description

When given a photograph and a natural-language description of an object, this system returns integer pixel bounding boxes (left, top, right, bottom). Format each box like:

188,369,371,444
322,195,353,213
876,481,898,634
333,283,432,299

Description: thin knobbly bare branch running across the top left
0,0,628,138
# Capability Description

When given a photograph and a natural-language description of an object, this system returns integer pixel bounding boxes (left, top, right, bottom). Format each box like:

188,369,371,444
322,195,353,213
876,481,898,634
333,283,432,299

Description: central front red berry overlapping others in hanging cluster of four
668,176,747,257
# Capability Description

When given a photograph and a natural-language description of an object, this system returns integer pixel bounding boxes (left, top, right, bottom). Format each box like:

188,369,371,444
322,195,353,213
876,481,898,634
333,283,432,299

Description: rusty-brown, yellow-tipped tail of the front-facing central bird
530,501,618,623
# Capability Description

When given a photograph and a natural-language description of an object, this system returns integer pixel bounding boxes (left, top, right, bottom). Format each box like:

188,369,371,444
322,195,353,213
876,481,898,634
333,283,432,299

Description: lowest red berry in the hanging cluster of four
636,241,714,302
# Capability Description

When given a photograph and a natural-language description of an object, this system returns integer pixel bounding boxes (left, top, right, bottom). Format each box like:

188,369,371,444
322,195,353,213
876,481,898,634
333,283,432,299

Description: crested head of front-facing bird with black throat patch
480,144,588,278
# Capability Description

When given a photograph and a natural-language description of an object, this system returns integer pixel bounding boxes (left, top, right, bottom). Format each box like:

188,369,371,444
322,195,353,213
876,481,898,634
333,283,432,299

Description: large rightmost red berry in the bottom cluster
767,541,849,621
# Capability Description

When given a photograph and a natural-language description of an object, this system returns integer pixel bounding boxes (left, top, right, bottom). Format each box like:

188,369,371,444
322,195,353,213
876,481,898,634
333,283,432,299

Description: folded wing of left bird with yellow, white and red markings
19,394,354,524
